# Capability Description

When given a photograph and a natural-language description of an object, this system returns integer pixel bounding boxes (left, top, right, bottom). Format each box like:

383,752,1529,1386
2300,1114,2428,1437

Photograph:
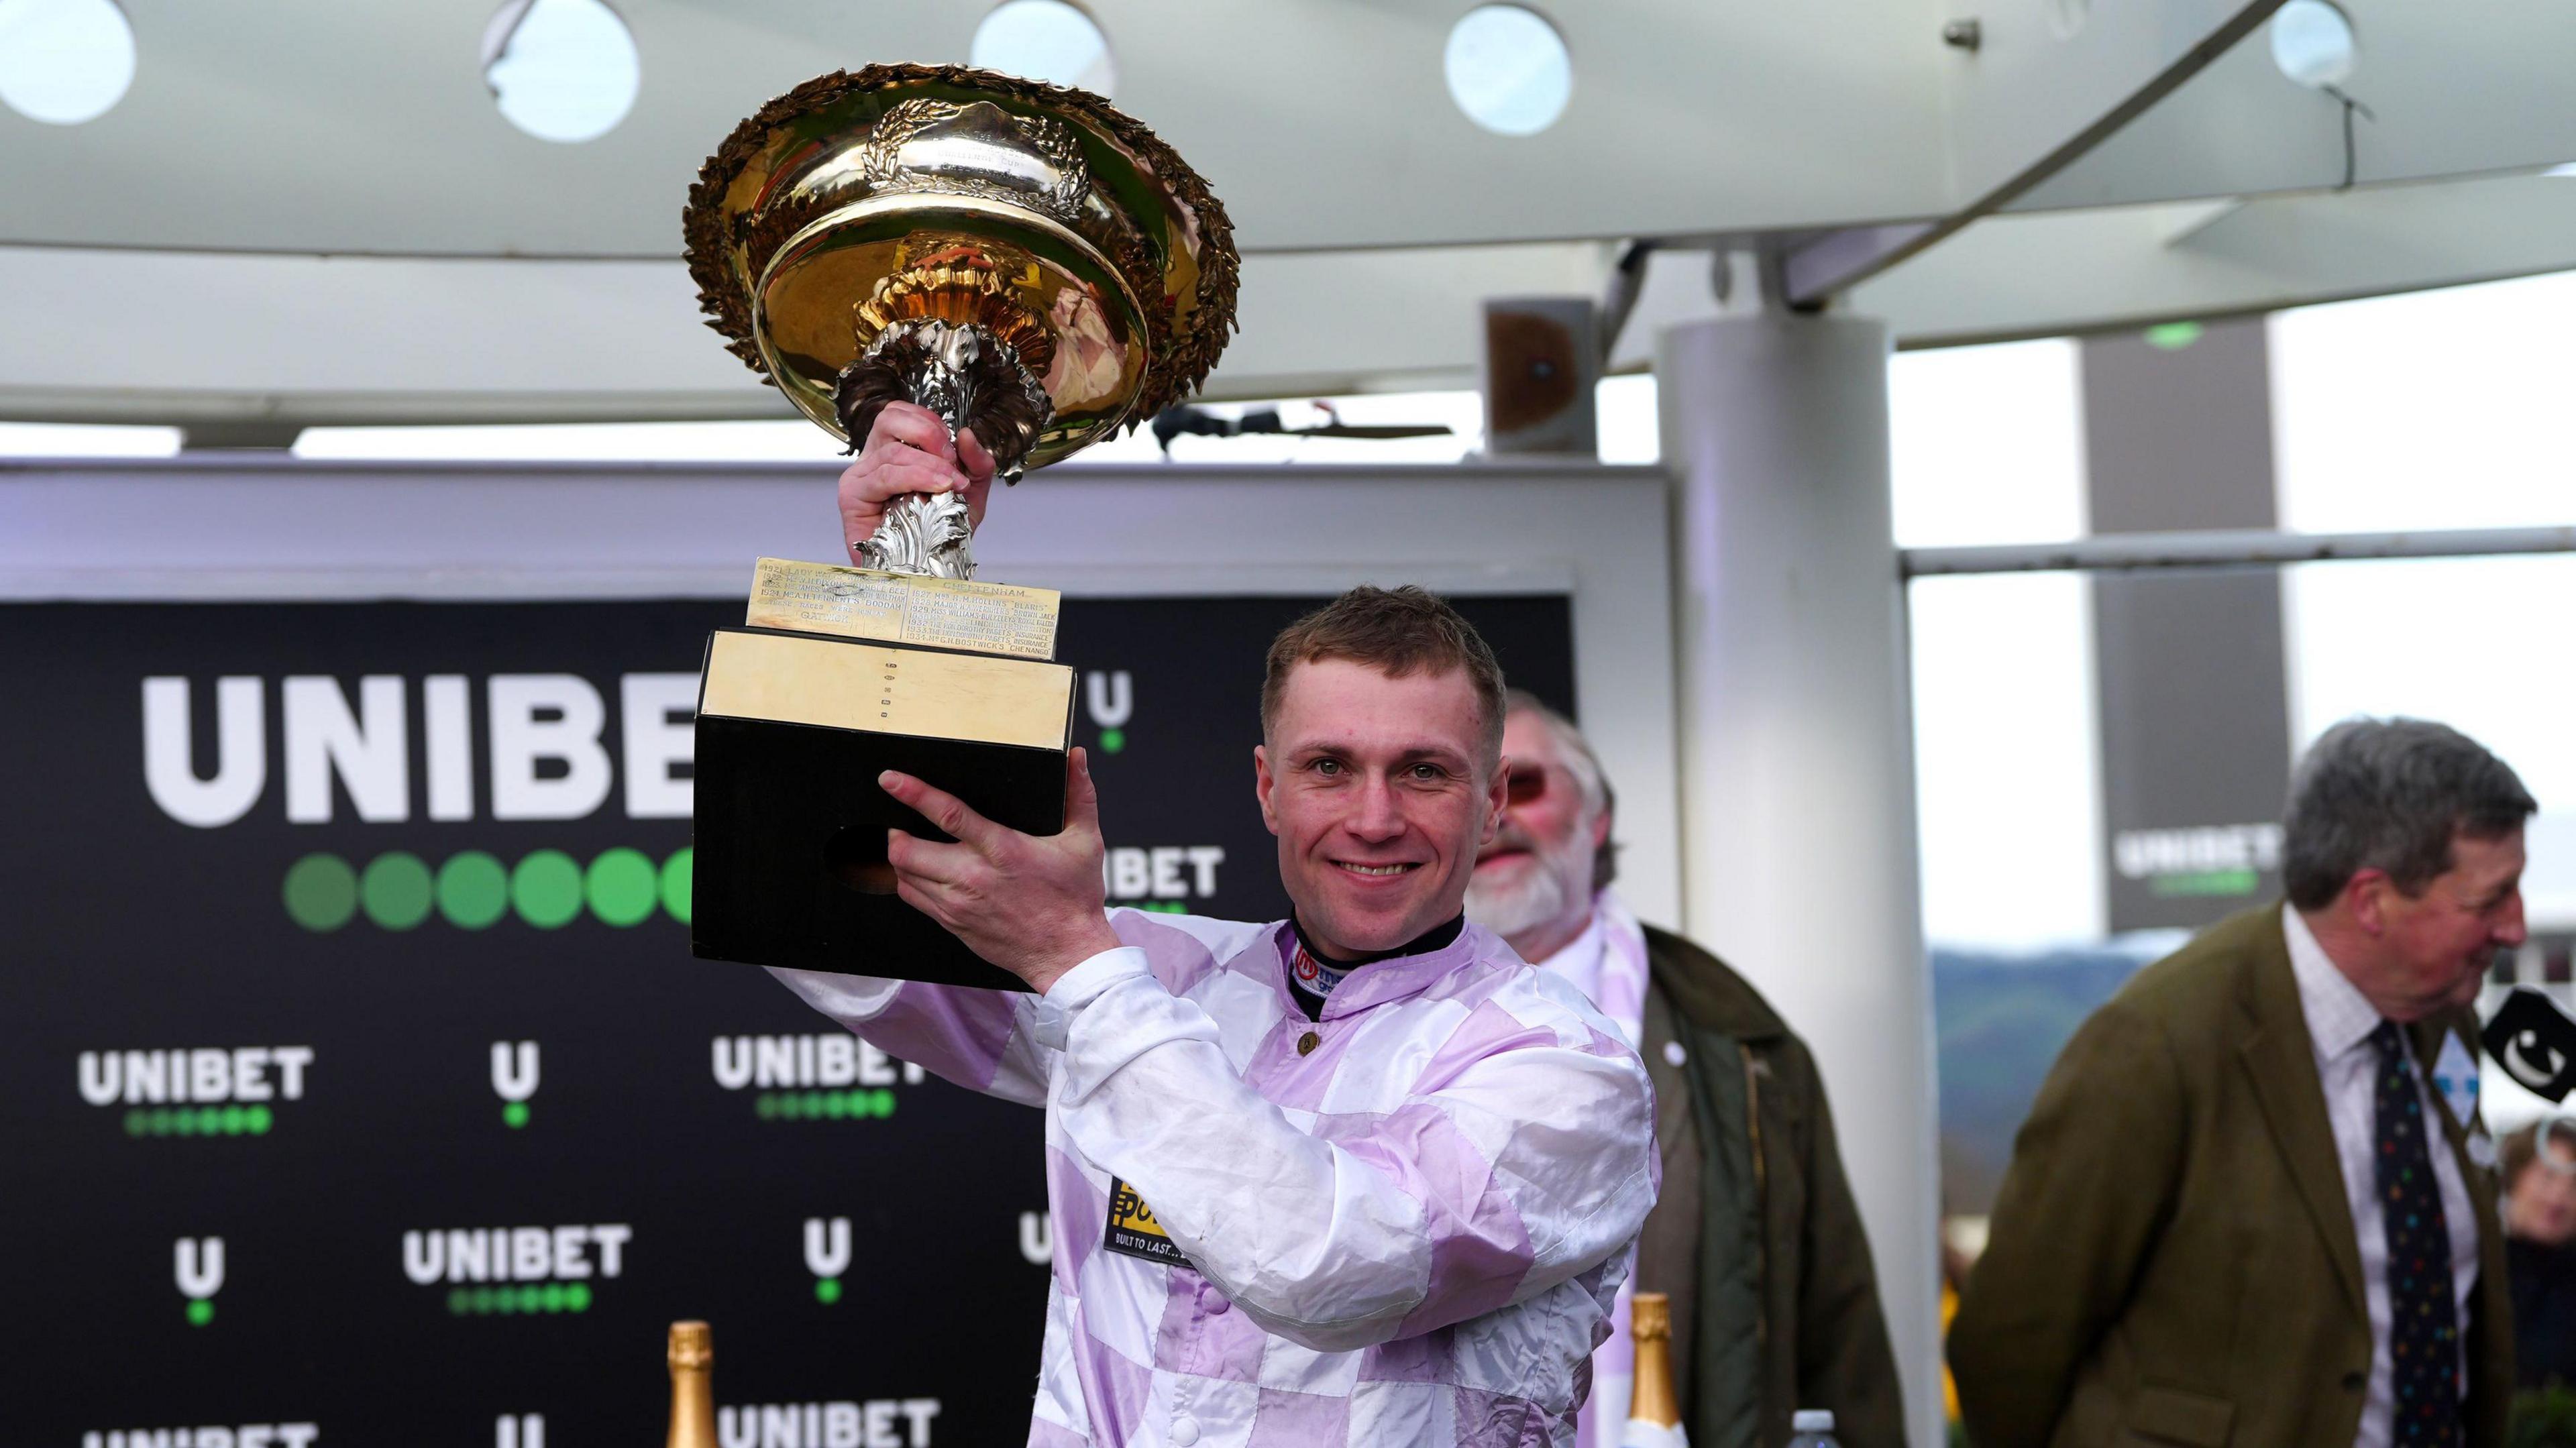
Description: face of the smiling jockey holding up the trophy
1252,659,1505,958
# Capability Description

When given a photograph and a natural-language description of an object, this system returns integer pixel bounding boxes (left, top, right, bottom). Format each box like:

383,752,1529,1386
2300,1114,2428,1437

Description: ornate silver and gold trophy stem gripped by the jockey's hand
837,317,1054,579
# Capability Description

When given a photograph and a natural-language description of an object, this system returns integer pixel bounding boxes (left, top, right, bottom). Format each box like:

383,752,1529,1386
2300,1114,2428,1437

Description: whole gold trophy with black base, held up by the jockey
685,64,1239,987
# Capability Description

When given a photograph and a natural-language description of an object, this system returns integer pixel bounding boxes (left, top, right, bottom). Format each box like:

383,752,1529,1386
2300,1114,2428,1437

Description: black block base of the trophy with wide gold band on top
690,613,1074,989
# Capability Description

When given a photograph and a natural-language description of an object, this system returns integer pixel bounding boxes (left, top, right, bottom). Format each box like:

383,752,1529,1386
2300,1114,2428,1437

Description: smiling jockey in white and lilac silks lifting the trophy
778,407,1656,1448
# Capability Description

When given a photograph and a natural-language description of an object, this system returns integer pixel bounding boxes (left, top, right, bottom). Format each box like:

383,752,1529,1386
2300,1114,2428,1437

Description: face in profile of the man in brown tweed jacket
2362,830,2527,1020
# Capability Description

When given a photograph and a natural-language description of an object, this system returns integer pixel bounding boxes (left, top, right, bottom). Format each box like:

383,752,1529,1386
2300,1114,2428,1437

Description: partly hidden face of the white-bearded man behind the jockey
1466,711,1610,940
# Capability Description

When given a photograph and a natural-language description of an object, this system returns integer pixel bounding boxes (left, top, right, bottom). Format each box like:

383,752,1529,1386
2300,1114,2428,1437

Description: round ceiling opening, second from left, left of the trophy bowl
484,0,644,142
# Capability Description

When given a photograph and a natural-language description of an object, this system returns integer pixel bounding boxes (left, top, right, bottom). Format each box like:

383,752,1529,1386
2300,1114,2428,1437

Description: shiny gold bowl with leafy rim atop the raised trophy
685,64,1239,546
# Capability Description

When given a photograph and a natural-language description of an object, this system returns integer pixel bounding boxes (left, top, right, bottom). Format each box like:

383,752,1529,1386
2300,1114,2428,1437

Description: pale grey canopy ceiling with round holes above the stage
0,0,2576,425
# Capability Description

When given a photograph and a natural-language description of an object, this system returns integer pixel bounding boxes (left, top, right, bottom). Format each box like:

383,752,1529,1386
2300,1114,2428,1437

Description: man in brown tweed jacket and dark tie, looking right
1950,719,2537,1448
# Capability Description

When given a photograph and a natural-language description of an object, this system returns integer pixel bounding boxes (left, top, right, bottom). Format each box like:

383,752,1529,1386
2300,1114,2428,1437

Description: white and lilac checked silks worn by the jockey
773,909,1659,1448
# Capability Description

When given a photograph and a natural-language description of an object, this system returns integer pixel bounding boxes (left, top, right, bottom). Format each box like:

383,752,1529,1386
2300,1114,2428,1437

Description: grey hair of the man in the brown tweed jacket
2279,719,2540,909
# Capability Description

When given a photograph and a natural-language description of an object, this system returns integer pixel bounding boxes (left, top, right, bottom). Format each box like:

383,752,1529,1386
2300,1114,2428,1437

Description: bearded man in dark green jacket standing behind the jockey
1466,691,1907,1448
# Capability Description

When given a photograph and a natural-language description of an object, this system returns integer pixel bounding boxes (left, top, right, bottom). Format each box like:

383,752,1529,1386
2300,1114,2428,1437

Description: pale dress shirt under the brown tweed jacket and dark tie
2279,904,2478,1448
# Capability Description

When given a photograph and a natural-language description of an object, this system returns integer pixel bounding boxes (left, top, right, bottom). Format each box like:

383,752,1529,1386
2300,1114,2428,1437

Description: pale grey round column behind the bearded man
1658,315,1942,1448
